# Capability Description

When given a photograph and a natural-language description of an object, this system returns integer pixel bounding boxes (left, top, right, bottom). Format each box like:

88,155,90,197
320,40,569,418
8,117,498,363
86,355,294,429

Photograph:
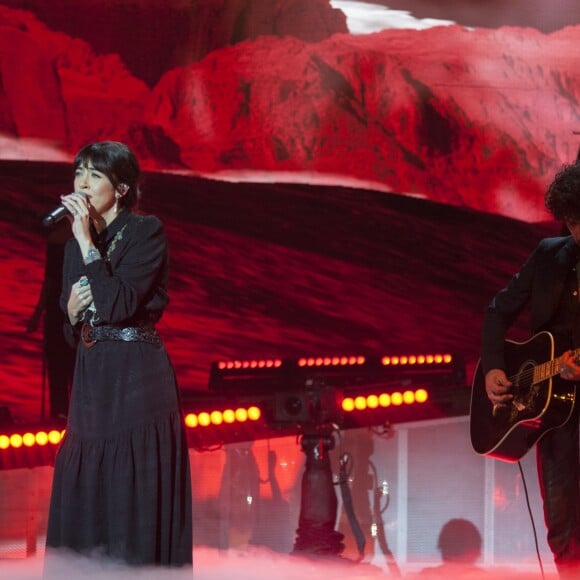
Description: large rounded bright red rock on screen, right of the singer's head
147,27,580,220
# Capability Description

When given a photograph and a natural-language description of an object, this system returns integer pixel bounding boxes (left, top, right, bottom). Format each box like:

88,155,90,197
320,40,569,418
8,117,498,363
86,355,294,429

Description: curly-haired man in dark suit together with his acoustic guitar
478,163,580,579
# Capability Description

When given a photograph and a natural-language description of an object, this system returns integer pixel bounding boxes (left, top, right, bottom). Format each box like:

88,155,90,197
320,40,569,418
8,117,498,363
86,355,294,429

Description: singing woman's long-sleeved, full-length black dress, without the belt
46,210,192,568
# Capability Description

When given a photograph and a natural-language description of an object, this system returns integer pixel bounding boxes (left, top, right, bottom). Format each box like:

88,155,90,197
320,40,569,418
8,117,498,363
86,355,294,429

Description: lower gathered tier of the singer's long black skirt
46,412,192,567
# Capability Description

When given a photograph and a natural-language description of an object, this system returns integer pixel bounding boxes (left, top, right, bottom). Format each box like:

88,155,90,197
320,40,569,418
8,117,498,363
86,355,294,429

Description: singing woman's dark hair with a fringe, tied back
73,141,141,209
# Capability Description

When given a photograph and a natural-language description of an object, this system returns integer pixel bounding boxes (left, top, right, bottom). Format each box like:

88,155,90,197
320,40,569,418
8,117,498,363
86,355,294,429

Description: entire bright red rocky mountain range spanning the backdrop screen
0,2,580,221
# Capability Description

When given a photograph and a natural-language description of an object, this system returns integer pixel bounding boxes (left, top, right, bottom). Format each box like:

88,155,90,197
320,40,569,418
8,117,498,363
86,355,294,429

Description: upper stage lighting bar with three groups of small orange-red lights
209,352,465,395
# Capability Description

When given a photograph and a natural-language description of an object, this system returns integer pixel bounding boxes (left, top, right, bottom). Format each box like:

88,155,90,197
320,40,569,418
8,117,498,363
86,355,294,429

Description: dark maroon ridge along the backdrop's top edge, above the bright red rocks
0,0,348,86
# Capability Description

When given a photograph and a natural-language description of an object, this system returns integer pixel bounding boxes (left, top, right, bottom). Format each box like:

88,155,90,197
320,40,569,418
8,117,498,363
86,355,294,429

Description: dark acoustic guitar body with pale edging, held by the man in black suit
470,332,576,462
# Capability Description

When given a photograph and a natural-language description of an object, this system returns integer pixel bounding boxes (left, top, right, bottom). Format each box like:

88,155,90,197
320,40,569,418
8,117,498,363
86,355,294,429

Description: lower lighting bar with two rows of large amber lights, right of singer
183,384,434,449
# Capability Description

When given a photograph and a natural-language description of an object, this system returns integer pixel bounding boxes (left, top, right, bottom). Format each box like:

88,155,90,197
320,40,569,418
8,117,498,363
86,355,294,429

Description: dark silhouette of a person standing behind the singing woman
26,220,75,422
